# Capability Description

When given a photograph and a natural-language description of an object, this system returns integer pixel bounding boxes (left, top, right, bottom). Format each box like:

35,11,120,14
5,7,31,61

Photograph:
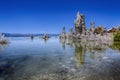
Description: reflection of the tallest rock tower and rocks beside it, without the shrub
74,41,113,64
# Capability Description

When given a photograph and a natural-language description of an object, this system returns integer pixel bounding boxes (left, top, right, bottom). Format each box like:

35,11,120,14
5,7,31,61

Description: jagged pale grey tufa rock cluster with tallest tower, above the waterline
60,12,113,43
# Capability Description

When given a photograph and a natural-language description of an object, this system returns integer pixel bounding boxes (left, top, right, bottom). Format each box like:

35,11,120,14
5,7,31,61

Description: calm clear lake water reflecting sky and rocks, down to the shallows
0,37,120,80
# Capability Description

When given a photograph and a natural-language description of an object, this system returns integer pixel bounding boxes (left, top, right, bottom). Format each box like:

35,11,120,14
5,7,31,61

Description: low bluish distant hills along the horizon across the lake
3,33,59,37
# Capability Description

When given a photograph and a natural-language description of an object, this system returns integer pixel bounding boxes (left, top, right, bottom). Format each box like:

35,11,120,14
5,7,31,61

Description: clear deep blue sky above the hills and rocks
0,0,120,33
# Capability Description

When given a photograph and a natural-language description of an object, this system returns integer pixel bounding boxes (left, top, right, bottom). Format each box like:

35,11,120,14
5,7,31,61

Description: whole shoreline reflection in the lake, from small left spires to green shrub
60,39,120,66
